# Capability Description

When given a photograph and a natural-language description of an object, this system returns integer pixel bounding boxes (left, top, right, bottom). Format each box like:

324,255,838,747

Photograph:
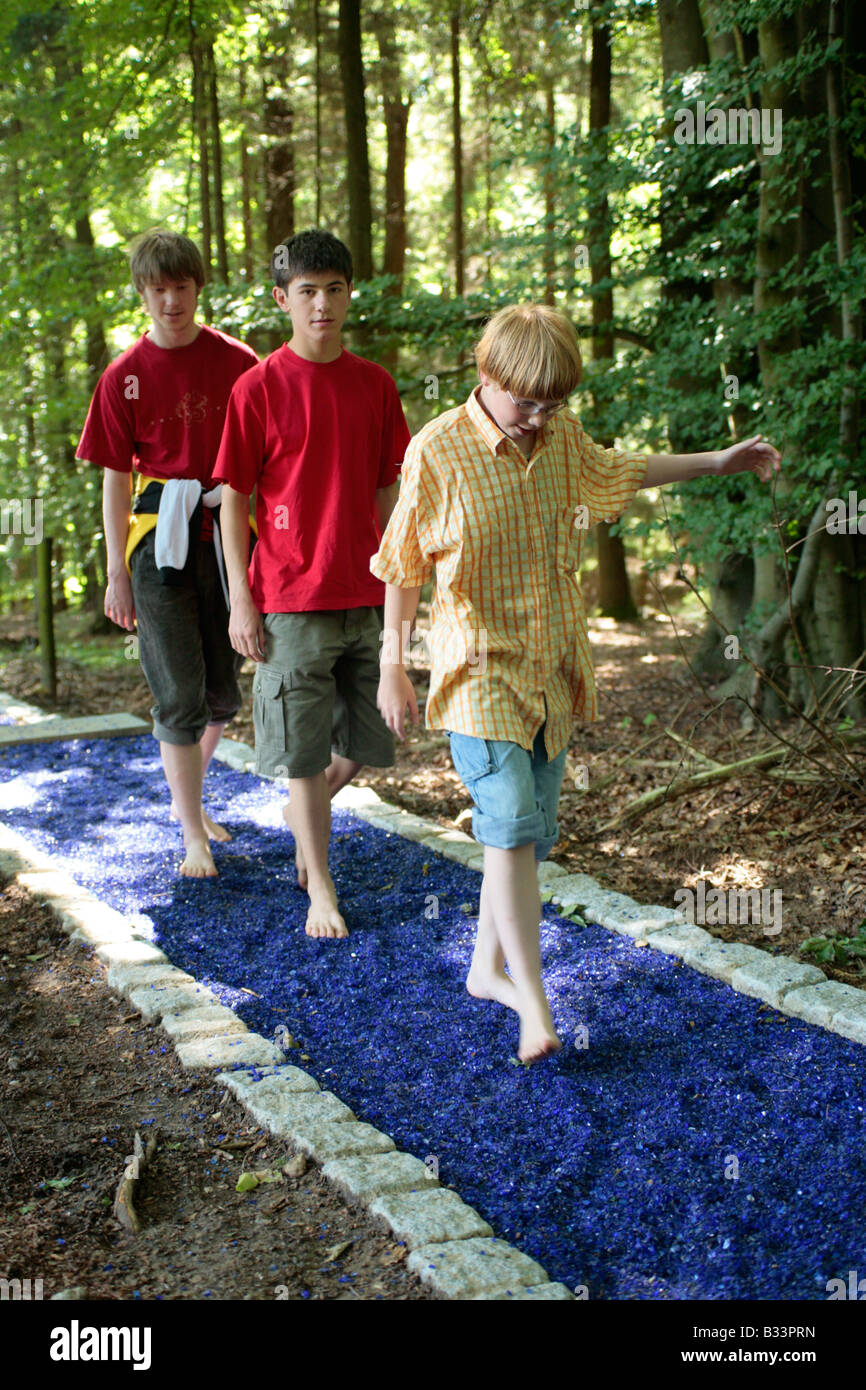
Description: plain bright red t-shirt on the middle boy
214,343,411,613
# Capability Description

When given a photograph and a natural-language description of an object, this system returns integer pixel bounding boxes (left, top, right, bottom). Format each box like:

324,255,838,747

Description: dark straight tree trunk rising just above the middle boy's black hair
339,0,373,279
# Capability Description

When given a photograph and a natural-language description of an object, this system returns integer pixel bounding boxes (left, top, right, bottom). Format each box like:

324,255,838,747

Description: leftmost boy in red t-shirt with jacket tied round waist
78,231,259,878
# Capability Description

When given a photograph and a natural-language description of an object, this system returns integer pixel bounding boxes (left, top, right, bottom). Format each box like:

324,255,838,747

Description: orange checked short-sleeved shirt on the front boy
370,388,646,759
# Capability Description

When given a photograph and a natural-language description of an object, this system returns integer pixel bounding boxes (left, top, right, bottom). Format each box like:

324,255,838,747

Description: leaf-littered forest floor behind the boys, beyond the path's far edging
0,582,866,988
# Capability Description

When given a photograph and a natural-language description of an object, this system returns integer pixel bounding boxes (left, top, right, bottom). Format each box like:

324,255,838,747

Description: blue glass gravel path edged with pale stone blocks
0,738,866,1300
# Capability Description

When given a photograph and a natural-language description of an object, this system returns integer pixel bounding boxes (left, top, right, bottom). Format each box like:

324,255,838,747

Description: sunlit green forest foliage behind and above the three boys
0,0,866,628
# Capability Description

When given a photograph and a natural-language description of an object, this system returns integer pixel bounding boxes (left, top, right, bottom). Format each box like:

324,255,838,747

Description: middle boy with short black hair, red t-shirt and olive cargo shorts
214,231,410,937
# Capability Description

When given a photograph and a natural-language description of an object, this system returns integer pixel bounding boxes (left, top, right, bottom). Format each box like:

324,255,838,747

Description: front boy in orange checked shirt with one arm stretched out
371,304,780,1062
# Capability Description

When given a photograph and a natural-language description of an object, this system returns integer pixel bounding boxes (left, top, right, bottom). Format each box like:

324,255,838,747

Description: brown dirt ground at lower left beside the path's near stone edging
0,883,431,1302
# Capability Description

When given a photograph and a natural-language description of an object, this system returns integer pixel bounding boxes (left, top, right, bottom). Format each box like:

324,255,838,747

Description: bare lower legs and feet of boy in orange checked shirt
467,845,562,1062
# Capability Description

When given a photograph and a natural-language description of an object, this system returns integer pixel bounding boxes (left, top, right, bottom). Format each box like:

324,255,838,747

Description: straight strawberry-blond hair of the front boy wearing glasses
475,304,584,400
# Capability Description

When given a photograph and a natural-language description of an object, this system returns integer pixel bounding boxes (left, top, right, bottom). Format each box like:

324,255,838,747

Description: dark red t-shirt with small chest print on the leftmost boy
76,324,259,539
